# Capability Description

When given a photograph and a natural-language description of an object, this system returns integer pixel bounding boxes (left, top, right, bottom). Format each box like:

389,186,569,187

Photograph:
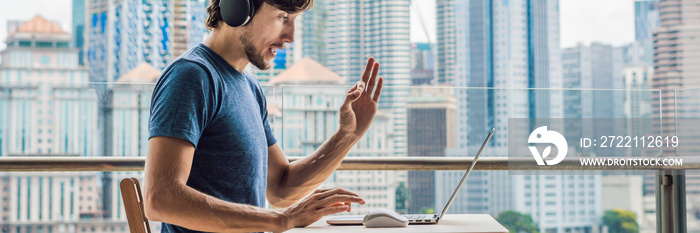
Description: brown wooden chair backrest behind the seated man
119,178,151,233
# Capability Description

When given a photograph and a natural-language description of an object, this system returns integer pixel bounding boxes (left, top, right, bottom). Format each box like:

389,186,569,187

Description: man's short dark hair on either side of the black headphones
205,0,314,30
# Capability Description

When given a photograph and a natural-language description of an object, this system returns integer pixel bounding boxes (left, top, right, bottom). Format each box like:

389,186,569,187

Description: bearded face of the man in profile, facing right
241,3,299,70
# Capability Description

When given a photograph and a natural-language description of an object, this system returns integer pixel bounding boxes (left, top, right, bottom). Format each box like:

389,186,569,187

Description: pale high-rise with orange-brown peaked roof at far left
0,16,99,161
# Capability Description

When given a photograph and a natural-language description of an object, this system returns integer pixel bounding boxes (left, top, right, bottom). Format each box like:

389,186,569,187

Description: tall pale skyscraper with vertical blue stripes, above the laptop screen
454,0,563,153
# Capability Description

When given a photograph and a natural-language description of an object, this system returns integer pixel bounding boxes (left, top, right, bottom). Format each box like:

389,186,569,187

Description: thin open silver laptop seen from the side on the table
326,128,496,225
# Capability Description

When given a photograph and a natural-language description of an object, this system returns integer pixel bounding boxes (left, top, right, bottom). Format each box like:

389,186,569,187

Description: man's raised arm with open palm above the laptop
267,58,383,208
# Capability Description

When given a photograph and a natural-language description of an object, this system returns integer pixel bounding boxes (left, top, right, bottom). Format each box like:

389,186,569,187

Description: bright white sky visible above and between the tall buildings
0,0,634,50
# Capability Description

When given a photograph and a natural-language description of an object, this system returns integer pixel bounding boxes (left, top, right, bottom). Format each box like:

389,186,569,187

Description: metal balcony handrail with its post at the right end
0,156,700,233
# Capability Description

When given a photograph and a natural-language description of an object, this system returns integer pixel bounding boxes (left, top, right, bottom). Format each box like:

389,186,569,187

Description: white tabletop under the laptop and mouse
286,214,508,233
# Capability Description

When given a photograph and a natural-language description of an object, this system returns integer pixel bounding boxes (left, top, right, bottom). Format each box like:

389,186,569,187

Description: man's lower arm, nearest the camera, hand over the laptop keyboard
144,137,364,232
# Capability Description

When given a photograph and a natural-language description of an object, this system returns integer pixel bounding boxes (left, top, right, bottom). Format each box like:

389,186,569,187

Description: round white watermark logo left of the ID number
527,126,569,165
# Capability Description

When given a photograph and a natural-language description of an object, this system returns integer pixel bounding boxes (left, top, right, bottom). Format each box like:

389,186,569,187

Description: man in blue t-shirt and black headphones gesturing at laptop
144,0,383,232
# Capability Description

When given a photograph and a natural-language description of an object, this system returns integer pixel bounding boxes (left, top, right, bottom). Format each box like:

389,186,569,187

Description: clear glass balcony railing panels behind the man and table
0,83,700,233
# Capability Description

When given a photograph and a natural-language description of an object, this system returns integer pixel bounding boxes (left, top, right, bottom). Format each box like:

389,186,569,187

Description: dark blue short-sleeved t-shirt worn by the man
148,44,277,232
